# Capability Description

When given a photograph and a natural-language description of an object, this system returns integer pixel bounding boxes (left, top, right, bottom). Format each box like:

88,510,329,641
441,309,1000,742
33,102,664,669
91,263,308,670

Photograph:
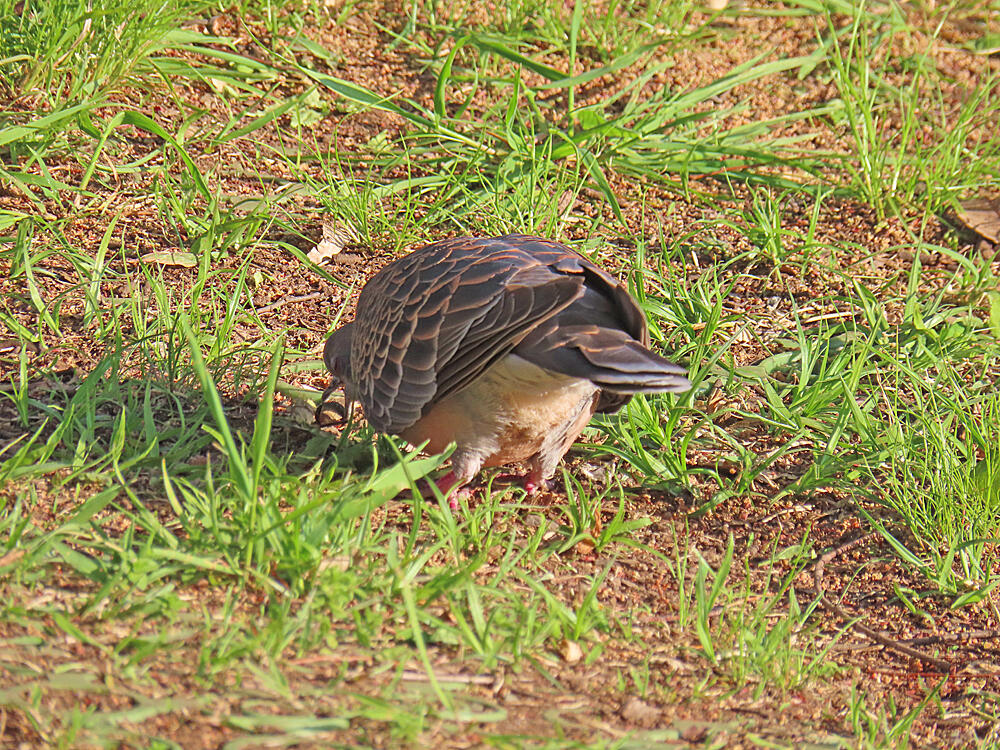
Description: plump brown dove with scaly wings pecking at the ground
316,234,691,508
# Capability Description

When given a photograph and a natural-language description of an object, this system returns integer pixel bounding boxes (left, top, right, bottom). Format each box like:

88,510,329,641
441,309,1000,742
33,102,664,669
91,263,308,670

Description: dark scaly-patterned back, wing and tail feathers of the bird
350,235,690,433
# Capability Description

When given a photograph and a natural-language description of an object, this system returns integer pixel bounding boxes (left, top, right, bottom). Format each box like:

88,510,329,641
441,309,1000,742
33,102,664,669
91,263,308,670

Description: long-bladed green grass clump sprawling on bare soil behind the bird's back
299,27,828,232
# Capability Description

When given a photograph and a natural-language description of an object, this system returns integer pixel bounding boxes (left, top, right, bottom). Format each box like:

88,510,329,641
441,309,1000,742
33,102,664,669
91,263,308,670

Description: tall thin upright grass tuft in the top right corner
825,4,1000,218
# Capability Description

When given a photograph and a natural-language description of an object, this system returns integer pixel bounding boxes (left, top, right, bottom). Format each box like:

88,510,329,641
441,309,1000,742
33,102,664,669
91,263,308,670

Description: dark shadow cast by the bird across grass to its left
0,356,378,502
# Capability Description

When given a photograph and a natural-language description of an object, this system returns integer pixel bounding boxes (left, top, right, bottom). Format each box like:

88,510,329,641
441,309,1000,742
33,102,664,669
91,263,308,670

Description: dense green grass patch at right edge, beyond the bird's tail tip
742,253,1000,594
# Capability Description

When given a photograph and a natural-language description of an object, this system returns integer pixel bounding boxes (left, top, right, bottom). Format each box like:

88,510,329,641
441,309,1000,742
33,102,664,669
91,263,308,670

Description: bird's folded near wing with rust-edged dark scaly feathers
352,238,584,432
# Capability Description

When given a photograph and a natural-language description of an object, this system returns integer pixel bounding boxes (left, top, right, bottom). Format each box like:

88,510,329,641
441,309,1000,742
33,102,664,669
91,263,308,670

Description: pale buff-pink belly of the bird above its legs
400,354,598,466
